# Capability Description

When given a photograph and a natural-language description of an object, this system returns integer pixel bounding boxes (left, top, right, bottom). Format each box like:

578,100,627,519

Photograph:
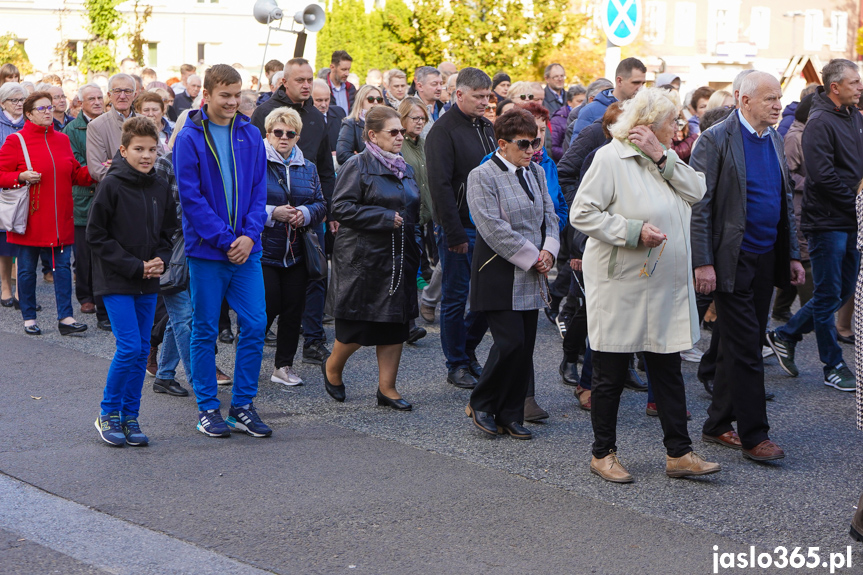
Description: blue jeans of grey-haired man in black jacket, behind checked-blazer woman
435,226,488,371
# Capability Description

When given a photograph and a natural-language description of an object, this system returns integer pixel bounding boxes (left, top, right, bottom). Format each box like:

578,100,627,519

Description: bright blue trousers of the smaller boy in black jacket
101,294,156,418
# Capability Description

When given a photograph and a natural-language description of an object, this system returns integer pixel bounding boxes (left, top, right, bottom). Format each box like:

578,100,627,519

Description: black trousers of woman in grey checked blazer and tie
470,310,538,424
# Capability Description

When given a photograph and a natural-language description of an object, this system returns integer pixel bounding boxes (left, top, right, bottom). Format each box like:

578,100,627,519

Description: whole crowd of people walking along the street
0,51,863,510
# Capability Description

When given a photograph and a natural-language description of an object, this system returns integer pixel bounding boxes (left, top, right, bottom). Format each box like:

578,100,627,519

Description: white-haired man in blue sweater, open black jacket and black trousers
689,72,805,461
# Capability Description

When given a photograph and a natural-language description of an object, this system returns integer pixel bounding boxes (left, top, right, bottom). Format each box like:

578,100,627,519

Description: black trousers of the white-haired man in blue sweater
703,251,774,449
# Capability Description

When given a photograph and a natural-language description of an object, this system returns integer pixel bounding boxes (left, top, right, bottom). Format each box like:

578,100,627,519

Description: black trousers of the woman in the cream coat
590,351,692,459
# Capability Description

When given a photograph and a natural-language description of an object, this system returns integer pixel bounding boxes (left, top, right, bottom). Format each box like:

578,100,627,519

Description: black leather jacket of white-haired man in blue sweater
689,113,800,292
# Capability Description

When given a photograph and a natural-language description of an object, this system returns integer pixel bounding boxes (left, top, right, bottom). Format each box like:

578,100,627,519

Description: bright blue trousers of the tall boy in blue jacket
189,252,267,411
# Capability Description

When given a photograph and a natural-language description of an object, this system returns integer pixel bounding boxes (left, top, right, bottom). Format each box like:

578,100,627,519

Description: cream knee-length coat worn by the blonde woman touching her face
569,140,706,353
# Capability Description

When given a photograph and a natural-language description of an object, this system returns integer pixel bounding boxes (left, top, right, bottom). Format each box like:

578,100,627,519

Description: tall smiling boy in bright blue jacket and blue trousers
173,64,273,437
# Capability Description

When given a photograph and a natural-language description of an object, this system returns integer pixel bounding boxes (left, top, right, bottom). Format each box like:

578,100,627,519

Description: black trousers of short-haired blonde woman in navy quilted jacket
261,262,309,369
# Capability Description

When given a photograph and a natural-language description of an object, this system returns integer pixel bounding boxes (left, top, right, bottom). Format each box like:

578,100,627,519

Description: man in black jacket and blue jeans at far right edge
767,59,863,391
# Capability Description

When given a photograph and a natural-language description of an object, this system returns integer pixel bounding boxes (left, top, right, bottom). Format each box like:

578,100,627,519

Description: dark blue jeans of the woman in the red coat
18,246,73,321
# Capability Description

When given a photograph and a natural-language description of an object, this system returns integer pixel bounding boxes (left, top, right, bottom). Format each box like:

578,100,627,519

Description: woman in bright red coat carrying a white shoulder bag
0,92,95,335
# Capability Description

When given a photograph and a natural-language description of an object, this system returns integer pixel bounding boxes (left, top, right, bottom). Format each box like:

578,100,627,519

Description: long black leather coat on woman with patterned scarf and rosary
328,149,420,323
